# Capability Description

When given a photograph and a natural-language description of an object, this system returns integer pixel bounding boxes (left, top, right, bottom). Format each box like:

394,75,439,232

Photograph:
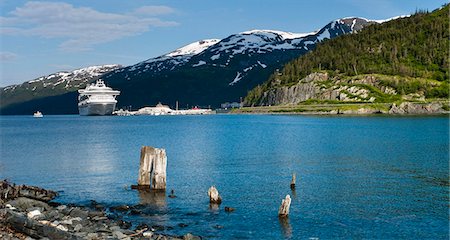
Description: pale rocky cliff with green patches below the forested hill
246,72,450,114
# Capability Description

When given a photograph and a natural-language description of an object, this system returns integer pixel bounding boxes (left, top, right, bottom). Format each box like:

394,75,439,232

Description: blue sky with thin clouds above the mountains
0,0,448,87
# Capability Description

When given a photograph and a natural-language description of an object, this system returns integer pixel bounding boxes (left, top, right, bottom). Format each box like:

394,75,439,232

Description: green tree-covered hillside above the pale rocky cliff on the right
247,4,450,102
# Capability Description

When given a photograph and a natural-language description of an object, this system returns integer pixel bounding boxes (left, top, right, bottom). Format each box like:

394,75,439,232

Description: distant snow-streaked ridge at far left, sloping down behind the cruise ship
0,64,122,111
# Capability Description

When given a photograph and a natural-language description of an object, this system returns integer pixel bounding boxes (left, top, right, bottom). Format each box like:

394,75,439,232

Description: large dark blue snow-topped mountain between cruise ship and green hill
98,17,376,107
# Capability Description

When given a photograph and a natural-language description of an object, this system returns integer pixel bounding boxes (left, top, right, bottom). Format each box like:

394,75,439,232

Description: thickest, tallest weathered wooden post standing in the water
137,146,167,190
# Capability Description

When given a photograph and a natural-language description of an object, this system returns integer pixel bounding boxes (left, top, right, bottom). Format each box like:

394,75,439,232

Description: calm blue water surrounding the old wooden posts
0,115,449,239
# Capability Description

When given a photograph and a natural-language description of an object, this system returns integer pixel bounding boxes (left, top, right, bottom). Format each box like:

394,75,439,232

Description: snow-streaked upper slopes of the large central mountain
109,17,377,87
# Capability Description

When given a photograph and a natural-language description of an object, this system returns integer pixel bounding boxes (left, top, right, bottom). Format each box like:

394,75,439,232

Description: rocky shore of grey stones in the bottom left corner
0,180,201,240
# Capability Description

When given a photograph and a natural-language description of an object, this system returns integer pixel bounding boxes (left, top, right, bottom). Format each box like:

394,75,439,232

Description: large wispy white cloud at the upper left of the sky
0,2,178,51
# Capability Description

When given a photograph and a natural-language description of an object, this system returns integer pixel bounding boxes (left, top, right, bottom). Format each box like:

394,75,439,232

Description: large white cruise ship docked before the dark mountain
78,79,120,116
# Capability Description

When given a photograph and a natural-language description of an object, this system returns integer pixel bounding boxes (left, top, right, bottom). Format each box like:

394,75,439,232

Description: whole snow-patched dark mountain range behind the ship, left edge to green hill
0,17,379,114
